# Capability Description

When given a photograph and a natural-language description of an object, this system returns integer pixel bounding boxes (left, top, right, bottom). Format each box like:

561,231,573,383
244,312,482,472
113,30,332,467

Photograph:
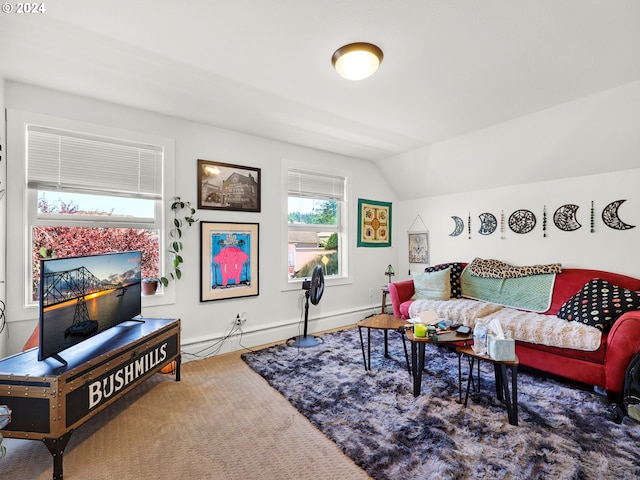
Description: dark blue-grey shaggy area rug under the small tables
243,328,640,479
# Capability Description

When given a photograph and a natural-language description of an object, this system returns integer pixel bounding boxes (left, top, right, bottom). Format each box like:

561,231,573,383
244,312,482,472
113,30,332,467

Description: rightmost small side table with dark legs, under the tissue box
456,346,520,427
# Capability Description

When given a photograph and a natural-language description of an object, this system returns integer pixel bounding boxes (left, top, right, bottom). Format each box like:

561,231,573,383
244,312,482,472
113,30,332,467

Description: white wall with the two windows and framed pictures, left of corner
4,82,397,360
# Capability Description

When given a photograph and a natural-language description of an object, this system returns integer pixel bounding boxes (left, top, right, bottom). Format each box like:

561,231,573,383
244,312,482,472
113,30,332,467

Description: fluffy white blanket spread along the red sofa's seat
409,298,602,351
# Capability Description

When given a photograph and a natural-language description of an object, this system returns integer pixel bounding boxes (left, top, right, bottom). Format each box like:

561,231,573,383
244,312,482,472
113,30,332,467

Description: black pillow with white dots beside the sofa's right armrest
558,278,640,332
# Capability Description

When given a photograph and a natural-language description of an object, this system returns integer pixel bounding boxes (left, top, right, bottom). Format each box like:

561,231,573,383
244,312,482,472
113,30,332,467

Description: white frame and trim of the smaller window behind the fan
280,160,354,291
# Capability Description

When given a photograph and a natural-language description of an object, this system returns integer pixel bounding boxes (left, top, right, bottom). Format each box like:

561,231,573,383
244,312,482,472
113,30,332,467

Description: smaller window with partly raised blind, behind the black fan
287,169,346,281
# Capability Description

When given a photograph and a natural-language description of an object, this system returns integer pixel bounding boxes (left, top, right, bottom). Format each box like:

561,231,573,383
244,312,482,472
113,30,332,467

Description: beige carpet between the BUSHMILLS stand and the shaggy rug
0,353,369,480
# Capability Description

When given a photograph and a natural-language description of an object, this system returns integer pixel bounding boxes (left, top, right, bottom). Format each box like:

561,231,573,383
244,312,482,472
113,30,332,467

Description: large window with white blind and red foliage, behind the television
26,125,163,300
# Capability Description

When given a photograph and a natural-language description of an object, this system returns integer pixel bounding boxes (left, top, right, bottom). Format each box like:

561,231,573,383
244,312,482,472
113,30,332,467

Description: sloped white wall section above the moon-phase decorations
380,81,640,200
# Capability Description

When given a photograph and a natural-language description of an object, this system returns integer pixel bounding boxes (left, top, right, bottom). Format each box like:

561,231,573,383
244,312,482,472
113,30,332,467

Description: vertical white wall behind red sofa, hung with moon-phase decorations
395,169,640,278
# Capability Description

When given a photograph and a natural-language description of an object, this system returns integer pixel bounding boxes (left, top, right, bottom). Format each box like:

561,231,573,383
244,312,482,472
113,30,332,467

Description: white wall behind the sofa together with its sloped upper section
392,82,640,278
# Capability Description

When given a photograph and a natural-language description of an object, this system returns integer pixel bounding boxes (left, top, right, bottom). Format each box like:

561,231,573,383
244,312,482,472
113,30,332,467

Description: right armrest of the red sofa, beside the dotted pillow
604,310,640,393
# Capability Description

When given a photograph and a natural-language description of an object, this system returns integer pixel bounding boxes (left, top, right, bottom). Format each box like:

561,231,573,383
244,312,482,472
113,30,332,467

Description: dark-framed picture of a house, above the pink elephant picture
198,160,260,212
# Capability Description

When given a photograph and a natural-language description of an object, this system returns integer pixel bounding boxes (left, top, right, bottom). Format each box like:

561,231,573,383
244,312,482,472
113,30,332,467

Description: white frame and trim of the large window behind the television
6,109,175,321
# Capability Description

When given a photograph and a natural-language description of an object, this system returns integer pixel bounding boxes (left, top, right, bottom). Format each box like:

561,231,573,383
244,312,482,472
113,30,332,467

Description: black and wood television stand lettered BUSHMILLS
0,318,181,480
